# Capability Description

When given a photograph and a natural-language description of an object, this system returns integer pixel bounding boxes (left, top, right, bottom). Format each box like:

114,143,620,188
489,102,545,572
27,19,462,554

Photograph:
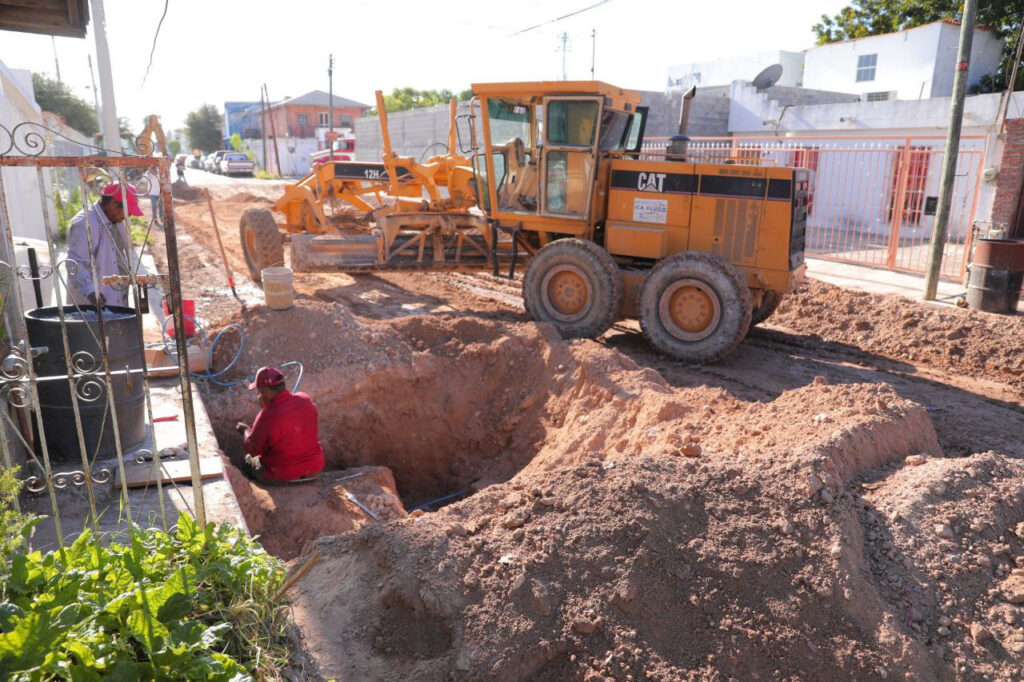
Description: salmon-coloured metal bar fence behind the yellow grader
643,135,984,280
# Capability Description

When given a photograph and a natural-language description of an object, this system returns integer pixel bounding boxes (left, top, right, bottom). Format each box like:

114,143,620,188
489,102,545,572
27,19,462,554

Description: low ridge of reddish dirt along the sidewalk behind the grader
768,280,1024,391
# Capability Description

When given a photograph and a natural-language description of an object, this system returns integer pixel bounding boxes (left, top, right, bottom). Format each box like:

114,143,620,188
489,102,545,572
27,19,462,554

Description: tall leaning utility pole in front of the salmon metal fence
925,0,978,301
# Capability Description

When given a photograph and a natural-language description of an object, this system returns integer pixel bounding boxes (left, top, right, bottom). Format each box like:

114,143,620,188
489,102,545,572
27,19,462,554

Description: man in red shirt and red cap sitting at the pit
237,367,324,483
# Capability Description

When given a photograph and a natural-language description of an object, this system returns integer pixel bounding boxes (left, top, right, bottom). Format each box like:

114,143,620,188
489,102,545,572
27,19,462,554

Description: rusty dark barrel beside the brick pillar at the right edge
967,240,1024,314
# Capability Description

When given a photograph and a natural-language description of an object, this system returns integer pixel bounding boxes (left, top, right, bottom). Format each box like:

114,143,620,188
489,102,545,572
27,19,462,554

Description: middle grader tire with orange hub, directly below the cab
522,239,623,339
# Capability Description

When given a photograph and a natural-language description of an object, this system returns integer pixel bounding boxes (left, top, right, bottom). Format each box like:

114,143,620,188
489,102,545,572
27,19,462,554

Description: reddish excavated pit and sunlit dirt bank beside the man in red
199,300,939,557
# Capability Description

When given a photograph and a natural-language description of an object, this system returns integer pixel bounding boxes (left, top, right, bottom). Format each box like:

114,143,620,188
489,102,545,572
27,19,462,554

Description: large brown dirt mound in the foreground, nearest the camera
292,444,1024,680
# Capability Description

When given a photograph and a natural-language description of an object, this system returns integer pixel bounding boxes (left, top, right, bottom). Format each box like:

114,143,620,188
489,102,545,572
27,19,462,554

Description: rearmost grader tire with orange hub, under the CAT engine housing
639,251,752,363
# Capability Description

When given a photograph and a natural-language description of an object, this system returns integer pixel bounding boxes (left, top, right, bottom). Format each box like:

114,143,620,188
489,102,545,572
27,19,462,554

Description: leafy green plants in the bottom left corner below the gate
0,513,287,681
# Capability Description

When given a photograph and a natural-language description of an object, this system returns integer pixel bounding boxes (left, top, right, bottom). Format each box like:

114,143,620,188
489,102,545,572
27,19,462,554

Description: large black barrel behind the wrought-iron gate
25,306,145,462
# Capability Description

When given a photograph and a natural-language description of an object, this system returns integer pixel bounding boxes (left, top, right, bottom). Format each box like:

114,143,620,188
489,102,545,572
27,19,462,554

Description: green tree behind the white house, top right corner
812,0,1024,93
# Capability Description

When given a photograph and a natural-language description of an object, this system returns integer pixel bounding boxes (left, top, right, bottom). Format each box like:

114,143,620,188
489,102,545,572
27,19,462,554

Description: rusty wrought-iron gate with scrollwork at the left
0,123,205,546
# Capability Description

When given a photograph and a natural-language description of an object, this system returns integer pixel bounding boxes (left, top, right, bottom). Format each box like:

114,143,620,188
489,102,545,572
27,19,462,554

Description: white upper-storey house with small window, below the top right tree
798,22,1002,100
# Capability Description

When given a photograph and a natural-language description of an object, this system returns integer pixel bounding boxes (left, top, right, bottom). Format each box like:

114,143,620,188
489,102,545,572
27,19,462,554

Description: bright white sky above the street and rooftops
0,0,848,131
